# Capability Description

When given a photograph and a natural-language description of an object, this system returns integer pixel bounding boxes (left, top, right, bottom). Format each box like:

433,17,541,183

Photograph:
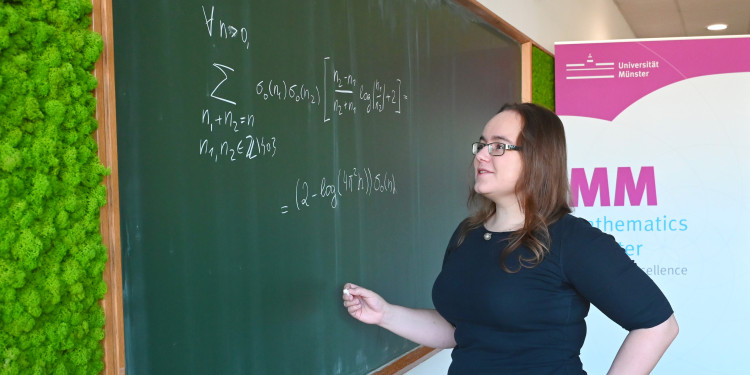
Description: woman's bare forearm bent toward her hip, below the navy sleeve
607,314,679,375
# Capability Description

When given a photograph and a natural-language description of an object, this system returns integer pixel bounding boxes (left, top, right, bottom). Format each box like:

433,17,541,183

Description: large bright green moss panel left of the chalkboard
0,0,107,374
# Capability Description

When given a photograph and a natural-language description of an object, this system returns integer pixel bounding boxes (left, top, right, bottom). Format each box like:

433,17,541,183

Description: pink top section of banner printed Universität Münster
555,36,750,121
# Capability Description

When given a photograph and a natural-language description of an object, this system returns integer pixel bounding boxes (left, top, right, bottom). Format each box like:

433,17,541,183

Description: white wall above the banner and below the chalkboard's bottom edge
407,0,635,375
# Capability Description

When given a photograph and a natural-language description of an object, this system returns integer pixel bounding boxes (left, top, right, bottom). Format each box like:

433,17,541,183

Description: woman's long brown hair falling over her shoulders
456,103,571,273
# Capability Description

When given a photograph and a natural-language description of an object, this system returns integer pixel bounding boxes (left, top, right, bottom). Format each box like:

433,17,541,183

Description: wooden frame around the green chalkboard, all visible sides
92,0,553,375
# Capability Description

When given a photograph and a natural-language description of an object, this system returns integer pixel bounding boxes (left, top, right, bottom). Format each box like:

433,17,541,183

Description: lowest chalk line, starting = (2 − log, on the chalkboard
281,168,398,214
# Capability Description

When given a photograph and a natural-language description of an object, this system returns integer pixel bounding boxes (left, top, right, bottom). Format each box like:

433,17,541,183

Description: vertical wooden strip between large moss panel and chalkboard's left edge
91,0,125,375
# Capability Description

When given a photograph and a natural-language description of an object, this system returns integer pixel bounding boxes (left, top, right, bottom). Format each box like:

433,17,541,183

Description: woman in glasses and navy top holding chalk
343,103,678,375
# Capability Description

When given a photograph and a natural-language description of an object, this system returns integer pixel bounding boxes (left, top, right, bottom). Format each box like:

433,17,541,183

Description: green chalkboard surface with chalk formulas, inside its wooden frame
113,0,521,375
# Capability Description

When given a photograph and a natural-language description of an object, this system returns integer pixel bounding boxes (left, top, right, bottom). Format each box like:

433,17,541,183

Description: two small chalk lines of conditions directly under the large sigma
198,109,277,163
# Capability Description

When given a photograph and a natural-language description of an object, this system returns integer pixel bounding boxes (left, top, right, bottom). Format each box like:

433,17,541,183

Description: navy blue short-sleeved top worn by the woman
432,215,672,375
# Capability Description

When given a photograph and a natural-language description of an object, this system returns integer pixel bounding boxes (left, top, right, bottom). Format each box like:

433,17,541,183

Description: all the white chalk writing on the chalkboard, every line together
196,6,409,214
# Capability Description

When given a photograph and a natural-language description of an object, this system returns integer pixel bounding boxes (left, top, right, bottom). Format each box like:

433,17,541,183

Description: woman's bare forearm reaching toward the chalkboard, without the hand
379,305,456,348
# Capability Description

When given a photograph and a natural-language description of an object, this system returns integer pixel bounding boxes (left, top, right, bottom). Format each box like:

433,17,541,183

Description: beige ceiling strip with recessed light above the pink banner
613,0,750,38
